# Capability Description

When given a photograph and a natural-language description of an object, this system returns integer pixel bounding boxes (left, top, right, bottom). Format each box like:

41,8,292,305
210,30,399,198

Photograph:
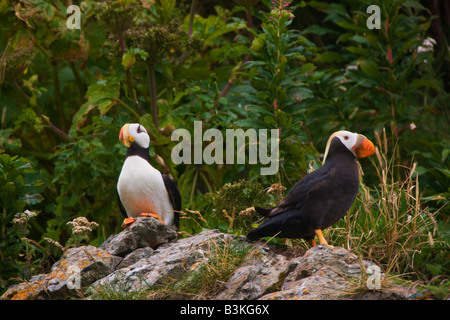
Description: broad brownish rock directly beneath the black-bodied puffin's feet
260,245,418,300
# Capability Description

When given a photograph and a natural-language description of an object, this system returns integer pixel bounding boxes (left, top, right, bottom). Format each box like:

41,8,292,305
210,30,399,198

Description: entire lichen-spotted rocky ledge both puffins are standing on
1,218,420,300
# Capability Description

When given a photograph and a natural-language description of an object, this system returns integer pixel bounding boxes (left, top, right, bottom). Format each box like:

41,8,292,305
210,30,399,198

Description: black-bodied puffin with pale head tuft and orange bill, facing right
247,131,374,246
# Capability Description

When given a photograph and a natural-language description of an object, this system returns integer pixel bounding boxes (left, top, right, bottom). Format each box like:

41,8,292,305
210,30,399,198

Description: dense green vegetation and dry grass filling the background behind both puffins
0,0,450,292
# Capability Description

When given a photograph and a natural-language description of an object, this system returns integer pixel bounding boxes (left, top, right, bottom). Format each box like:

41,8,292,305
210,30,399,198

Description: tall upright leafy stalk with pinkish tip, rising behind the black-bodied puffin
235,0,316,185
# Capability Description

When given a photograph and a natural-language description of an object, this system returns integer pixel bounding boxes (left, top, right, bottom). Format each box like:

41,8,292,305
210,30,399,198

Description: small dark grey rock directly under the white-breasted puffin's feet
100,217,177,257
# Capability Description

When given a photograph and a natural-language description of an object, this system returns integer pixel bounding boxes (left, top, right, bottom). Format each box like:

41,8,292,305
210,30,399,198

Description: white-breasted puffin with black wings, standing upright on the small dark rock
117,123,181,230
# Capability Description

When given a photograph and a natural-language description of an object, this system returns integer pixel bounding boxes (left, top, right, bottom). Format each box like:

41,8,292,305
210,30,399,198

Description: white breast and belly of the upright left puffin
117,156,174,226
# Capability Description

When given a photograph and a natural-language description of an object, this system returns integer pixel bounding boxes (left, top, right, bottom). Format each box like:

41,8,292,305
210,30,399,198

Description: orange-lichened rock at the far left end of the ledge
1,246,122,300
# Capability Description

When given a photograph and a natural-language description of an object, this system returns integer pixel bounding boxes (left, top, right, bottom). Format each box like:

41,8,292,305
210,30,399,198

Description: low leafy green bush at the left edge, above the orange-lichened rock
0,154,43,290
